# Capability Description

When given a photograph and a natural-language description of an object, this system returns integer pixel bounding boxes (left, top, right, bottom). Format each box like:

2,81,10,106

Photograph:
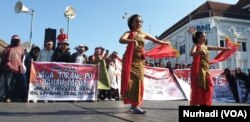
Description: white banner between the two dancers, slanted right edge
143,66,186,100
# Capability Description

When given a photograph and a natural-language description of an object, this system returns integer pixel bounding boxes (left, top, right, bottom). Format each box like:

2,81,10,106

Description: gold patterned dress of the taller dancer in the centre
122,31,145,105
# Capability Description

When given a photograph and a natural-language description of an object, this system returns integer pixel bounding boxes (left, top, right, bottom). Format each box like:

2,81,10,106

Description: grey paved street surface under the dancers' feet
0,100,249,122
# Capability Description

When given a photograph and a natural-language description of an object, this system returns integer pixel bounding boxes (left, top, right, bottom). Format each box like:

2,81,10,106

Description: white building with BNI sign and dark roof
145,0,250,69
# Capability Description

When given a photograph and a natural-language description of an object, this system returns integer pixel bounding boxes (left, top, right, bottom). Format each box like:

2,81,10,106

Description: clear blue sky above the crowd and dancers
0,0,238,56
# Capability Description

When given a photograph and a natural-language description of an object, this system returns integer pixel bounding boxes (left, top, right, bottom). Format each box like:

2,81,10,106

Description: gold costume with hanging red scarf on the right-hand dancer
190,44,214,106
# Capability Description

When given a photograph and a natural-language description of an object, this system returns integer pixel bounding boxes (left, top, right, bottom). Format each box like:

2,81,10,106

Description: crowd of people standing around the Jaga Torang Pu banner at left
0,29,120,103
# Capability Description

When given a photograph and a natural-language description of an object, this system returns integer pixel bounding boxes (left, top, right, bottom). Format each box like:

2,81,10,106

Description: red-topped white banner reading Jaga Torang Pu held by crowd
28,62,98,101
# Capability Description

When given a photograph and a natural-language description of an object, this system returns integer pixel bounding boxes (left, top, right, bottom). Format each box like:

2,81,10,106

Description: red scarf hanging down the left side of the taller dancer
121,32,135,96
